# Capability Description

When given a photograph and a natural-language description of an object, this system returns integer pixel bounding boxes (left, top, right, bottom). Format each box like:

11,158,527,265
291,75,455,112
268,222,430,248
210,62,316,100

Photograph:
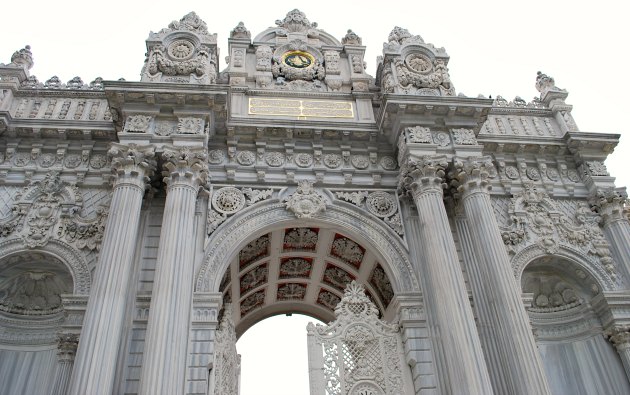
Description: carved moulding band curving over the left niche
0,239,92,295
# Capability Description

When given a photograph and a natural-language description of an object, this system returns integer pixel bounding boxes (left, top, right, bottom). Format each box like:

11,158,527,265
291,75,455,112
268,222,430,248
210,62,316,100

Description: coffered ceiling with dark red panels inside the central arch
220,226,394,336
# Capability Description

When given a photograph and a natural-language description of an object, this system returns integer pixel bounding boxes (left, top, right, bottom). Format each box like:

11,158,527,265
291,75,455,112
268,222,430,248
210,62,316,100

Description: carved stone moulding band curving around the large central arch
195,200,420,293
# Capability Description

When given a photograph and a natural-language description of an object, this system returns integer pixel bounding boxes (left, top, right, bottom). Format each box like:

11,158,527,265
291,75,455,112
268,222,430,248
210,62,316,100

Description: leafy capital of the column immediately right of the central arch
398,155,448,196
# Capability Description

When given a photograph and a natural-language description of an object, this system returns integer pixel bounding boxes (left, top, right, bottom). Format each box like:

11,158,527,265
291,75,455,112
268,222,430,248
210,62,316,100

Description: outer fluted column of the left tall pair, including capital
69,143,155,395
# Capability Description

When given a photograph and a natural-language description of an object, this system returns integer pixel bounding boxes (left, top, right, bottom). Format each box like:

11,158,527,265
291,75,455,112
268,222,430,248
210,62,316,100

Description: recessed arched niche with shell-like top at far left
0,249,81,394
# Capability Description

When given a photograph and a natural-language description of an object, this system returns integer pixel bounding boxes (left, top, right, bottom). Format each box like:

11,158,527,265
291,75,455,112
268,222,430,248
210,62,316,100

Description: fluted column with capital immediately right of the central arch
401,156,493,395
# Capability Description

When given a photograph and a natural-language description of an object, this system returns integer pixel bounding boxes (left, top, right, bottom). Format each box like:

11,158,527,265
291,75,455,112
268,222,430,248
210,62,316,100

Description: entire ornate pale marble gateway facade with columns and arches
0,10,630,395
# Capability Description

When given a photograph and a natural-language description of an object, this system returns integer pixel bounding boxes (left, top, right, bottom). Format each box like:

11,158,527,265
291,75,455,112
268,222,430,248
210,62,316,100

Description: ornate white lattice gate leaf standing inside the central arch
308,281,408,395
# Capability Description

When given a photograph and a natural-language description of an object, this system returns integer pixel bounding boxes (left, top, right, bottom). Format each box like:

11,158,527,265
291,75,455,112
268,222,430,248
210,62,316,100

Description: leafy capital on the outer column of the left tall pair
107,143,157,190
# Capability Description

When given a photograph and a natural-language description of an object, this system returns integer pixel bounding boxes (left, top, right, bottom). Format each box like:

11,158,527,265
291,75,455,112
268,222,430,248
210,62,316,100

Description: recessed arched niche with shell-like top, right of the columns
520,255,630,395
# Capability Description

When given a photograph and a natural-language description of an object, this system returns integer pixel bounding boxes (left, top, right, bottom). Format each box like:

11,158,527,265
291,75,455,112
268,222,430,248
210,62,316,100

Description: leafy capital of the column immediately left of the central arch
162,146,208,188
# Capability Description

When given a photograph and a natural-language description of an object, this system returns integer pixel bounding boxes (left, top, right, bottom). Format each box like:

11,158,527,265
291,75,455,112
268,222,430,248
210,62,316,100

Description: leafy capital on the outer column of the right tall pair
449,156,494,198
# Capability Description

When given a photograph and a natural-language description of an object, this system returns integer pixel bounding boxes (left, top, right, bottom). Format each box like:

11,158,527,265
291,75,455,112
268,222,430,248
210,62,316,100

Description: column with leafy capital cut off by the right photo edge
592,190,630,288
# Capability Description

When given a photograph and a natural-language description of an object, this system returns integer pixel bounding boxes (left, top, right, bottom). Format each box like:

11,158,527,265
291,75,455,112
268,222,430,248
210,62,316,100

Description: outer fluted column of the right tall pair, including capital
453,157,550,395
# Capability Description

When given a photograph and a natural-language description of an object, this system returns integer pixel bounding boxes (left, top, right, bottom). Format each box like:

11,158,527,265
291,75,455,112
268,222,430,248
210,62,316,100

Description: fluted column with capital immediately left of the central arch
140,147,208,395
